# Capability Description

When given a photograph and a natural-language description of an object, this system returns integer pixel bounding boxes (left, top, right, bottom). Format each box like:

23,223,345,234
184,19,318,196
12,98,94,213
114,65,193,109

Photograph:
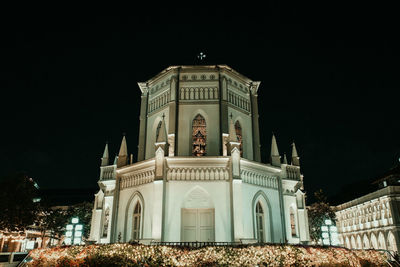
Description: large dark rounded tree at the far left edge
0,172,39,231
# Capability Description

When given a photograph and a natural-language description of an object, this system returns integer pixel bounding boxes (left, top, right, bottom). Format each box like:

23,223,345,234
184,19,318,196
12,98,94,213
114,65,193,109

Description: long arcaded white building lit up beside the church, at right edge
336,166,400,253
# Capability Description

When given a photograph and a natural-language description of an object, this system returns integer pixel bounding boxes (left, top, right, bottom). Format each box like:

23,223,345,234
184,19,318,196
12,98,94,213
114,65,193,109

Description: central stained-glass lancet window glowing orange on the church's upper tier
192,114,207,157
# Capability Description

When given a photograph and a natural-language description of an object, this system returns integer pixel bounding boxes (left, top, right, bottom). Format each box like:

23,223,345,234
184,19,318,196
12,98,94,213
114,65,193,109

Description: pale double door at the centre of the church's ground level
181,209,214,242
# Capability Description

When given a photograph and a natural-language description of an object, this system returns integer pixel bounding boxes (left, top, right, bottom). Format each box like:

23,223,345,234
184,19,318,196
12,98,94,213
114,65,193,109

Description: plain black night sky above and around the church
0,4,400,205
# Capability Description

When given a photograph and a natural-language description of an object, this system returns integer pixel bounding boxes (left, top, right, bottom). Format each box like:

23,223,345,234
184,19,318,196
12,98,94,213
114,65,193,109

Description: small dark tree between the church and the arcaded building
308,189,336,244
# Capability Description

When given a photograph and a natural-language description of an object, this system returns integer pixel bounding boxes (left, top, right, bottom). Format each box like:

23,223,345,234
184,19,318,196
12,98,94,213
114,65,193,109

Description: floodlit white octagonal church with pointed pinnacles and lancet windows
89,65,309,244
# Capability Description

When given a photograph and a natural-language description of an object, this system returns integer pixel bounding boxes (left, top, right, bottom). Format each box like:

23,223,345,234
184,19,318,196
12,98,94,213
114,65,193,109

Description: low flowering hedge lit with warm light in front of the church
28,243,388,267
